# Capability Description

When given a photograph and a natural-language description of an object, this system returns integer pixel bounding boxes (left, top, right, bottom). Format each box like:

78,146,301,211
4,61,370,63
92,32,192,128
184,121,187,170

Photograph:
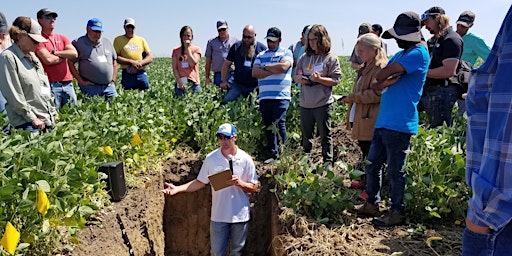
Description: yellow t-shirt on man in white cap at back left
114,35,151,69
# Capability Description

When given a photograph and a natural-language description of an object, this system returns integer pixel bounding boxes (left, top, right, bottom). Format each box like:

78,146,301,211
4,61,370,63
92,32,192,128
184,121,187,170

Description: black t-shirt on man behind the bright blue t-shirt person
425,27,463,86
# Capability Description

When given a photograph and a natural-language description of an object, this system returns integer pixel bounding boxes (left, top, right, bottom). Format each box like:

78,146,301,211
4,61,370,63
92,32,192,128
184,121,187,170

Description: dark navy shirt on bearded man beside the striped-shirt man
226,41,267,87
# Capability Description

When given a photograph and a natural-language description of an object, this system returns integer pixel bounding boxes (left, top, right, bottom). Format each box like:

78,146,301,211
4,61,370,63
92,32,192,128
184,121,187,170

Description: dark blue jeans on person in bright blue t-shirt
366,128,411,214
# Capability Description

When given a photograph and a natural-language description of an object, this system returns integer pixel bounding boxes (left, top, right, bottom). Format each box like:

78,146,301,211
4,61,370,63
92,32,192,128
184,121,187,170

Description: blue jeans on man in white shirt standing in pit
210,221,249,256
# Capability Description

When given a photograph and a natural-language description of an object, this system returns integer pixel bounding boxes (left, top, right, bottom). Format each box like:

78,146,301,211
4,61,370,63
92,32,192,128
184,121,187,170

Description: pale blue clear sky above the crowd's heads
0,0,512,57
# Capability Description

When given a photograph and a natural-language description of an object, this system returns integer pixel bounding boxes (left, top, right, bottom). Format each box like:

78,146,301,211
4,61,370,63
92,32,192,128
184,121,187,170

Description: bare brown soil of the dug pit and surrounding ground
71,127,462,256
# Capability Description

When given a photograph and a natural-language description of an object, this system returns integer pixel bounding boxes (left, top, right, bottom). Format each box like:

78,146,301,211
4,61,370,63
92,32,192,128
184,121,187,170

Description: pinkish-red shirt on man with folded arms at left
35,33,73,83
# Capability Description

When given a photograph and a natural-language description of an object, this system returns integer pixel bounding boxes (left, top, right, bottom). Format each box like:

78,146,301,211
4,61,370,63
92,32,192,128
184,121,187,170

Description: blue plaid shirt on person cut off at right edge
466,4,512,230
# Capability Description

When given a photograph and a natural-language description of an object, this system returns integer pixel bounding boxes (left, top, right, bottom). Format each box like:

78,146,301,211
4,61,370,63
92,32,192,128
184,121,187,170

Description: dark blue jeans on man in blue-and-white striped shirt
259,99,290,159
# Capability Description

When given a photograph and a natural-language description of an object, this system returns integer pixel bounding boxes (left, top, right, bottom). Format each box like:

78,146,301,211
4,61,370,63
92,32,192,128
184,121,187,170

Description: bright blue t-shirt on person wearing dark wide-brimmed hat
375,46,430,134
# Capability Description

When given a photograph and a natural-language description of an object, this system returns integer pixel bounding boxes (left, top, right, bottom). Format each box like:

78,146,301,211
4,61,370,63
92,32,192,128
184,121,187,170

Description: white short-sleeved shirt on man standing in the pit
197,148,258,223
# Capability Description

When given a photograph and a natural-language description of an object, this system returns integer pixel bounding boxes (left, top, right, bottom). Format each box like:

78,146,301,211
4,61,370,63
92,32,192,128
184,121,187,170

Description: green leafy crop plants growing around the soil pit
0,57,470,255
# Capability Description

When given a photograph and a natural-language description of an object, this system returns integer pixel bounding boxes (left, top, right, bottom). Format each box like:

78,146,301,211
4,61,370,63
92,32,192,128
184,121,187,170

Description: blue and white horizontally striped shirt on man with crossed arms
254,47,293,100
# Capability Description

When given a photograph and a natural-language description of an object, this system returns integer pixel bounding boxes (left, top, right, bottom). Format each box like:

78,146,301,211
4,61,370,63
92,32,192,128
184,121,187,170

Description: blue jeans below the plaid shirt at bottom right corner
462,222,512,256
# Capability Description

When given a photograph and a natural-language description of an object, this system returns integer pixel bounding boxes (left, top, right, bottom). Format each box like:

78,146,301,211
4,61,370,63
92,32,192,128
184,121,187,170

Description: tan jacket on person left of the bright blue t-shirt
346,62,386,141
